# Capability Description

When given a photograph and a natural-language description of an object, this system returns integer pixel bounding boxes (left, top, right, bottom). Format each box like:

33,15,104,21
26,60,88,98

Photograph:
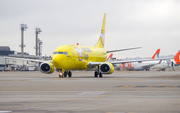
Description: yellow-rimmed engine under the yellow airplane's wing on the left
40,62,54,74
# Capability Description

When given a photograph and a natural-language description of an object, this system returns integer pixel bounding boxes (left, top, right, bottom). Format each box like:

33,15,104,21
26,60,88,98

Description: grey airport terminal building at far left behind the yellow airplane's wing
0,46,51,71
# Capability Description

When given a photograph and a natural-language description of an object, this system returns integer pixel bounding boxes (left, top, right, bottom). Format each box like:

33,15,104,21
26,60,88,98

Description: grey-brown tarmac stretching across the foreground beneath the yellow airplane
0,71,180,113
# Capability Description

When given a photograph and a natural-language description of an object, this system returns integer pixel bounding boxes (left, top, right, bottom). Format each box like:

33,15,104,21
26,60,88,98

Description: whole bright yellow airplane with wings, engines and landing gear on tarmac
5,13,177,77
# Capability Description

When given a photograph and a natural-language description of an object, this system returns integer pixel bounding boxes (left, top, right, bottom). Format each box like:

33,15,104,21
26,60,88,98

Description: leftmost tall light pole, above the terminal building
19,24,28,57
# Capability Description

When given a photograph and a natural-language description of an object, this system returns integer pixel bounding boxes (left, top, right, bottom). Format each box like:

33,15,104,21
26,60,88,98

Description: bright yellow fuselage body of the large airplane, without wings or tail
52,45,107,70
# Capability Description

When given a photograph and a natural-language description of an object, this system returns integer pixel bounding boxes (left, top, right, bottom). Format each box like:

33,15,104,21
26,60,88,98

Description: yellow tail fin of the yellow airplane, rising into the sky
94,13,106,48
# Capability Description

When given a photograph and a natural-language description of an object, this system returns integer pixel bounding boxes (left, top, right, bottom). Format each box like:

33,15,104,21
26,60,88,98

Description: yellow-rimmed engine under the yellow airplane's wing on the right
100,62,114,74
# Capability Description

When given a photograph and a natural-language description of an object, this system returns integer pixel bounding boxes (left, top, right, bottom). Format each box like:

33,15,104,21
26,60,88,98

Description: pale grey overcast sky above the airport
0,0,180,58
